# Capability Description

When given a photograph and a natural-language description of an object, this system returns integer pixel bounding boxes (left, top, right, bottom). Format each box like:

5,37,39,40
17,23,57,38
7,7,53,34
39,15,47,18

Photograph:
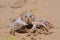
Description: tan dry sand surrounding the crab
0,0,60,40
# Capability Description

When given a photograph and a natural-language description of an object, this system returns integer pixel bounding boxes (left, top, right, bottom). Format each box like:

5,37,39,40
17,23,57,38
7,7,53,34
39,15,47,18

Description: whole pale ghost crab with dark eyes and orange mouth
10,13,53,35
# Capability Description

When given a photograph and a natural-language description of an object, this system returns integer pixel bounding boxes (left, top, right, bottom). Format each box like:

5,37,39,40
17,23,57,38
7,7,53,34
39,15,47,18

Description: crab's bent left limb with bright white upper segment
10,18,28,35
